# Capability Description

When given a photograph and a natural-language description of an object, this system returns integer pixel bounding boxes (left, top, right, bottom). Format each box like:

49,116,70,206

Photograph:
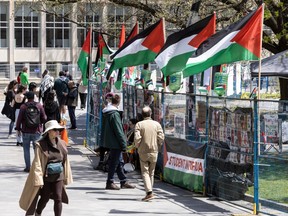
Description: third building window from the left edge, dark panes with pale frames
46,7,71,47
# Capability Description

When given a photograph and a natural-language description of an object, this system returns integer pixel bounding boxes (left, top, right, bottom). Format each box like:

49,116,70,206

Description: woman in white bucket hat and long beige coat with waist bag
19,120,73,216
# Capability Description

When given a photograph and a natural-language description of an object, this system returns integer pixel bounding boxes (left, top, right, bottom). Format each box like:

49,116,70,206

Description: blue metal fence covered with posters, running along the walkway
87,79,288,214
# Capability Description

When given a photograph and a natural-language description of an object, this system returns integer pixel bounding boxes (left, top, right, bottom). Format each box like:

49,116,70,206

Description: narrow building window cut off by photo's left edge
0,2,8,47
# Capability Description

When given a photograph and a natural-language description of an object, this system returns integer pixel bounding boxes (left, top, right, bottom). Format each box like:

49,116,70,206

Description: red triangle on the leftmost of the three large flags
142,19,165,53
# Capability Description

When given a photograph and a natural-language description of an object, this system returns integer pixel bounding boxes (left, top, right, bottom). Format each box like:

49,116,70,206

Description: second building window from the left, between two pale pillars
15,4,40,47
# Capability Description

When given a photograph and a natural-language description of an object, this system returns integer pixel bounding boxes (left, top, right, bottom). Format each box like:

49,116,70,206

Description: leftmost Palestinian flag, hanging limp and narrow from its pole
77,28,92,86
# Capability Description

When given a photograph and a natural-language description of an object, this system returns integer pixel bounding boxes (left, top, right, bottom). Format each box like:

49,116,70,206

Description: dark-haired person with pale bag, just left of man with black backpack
12,84,27,146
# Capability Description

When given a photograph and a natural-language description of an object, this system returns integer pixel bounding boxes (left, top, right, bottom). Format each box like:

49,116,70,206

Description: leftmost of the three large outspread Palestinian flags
107,19,165,78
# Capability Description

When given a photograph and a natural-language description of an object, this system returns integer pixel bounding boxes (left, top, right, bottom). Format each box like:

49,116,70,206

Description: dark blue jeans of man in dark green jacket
107,149,126,184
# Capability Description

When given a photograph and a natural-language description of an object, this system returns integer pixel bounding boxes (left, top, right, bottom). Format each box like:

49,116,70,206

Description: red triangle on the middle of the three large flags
188,13,216,48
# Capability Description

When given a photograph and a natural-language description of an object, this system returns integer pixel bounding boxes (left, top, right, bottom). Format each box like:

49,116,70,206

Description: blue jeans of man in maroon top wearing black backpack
23,133,40,169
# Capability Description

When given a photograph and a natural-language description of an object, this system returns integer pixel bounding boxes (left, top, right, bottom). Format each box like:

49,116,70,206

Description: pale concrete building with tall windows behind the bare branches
0,0,135,81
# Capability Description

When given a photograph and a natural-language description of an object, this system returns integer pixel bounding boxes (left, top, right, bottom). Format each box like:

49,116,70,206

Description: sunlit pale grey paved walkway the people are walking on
0,101,288,216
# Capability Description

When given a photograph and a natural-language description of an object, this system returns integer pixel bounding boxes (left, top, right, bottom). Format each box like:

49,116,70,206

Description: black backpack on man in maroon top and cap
25,103,41,128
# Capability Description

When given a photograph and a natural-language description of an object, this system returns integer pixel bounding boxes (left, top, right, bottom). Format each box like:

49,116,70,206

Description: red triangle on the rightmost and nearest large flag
231,5,264,58
